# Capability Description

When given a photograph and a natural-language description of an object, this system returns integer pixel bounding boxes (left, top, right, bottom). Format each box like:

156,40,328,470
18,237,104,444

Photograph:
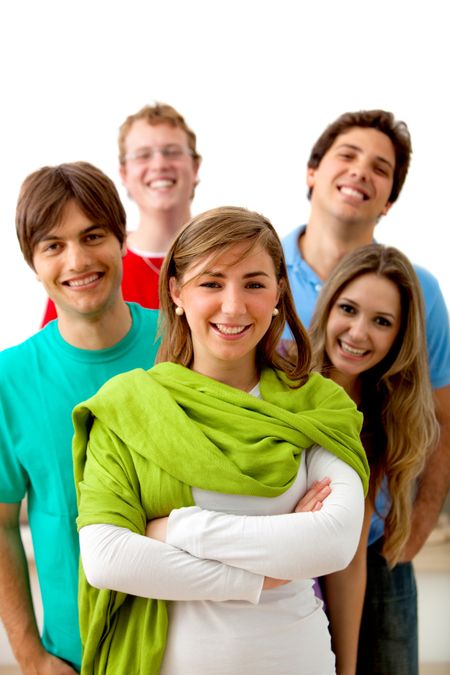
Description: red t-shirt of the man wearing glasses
41,249,164,327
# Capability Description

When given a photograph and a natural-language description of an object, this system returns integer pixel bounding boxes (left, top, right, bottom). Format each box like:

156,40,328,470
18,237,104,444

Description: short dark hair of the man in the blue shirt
308,110,412,203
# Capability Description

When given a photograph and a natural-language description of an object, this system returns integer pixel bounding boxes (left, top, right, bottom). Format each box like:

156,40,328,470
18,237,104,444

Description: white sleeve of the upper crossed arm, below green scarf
167,447,364,580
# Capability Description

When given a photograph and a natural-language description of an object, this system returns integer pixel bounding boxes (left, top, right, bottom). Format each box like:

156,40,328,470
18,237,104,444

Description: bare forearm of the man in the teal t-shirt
0,525,45,673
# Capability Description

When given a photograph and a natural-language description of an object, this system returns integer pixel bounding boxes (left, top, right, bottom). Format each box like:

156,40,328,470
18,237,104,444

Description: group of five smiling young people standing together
0,104,450,675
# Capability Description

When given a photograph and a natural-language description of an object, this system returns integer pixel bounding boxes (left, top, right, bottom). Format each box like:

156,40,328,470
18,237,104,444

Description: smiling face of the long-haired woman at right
326,273,401,382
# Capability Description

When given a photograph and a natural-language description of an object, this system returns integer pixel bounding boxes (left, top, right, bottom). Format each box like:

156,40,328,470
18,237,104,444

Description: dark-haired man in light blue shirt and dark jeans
283,110,450,675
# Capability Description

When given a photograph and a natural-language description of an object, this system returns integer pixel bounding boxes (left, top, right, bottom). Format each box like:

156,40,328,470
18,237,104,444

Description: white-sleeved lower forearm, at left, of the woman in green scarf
80,524,264,603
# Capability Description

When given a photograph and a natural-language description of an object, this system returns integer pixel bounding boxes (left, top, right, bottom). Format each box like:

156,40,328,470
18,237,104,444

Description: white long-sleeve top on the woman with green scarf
80,447,364,675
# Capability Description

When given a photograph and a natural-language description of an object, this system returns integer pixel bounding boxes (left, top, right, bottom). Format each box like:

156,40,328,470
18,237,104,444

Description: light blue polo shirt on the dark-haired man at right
283,225,450,544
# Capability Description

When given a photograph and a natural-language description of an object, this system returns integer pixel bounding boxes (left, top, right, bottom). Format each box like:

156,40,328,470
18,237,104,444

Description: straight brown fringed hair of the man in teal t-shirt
16,162,126,267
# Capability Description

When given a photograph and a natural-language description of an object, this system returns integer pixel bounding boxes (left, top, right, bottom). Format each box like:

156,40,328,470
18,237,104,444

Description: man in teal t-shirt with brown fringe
0,162,157,675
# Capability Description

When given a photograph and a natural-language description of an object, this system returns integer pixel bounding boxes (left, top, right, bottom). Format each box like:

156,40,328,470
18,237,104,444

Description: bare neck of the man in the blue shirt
299,213,375,281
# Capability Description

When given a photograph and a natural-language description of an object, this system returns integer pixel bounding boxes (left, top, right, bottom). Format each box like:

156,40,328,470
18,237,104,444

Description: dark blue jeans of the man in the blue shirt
357,539,419,675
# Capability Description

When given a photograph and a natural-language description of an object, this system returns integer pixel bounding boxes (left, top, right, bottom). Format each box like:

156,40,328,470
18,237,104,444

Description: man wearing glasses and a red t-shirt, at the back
42,103,201,325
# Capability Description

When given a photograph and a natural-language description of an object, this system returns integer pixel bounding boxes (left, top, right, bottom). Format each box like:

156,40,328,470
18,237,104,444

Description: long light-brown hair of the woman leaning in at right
310,244,439,565
